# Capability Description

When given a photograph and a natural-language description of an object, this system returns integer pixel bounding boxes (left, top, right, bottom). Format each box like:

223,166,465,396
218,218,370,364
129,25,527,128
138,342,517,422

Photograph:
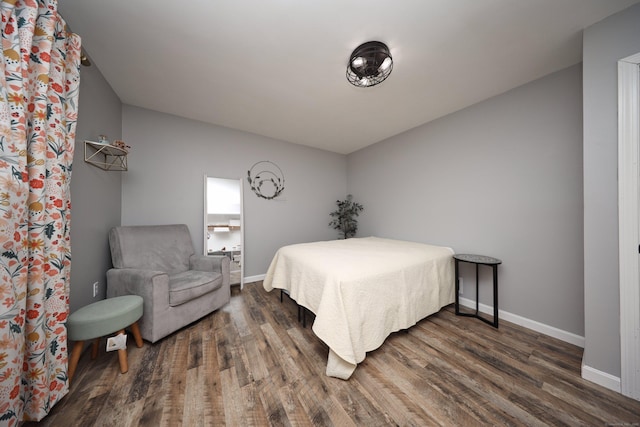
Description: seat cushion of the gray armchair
169,270,222,307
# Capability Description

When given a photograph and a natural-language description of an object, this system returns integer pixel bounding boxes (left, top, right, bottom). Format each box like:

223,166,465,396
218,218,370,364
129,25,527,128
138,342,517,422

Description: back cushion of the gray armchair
109,224,195,274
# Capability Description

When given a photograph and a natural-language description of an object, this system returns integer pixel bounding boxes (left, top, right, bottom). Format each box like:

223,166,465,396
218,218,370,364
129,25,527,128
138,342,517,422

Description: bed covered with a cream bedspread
263,237,455,380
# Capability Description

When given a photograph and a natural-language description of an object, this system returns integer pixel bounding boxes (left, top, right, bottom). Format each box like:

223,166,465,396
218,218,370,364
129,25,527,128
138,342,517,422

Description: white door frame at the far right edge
618,53,640,400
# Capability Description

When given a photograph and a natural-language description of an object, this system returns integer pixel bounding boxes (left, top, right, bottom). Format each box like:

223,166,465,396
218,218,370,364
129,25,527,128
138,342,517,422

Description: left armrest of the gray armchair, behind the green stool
107,268,169,309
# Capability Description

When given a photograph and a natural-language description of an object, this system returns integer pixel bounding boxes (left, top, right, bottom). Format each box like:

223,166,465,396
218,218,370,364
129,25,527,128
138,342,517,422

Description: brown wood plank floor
26,282,640,426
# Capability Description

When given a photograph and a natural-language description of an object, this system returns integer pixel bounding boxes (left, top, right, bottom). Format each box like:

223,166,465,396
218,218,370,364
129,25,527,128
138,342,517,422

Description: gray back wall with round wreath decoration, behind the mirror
122,105,347,276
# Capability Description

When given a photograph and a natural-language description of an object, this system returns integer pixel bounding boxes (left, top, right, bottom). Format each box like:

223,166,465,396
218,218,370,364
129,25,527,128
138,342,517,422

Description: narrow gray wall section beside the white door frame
583,5,640,377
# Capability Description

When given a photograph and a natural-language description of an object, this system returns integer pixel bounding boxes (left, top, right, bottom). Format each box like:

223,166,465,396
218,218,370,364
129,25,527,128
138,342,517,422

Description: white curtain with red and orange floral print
0,0,80,426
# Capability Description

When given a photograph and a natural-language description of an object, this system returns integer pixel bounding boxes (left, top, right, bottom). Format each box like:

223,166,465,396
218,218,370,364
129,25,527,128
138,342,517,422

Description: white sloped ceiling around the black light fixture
59,0,640,154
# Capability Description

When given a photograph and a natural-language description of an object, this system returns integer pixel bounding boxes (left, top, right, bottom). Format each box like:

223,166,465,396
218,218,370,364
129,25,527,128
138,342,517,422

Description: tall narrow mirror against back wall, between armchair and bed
204,176,244,288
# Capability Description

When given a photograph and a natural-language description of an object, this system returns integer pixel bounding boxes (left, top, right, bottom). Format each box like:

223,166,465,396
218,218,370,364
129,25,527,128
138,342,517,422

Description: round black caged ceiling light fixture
347,42,393,87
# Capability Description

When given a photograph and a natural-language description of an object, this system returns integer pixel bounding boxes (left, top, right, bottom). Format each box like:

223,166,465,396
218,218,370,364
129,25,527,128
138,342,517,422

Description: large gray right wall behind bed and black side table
347,65,584,335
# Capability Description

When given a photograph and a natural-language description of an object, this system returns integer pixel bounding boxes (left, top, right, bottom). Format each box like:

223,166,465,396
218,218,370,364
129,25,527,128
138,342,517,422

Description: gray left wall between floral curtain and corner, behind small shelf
69,55,126,312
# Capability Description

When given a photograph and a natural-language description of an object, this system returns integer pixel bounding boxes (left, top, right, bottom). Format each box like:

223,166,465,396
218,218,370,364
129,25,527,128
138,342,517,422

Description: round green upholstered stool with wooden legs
67,295,142,383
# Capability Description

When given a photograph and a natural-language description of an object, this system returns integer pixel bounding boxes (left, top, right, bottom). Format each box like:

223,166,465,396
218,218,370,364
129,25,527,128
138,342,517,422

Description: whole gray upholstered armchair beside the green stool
107,224,231,343
